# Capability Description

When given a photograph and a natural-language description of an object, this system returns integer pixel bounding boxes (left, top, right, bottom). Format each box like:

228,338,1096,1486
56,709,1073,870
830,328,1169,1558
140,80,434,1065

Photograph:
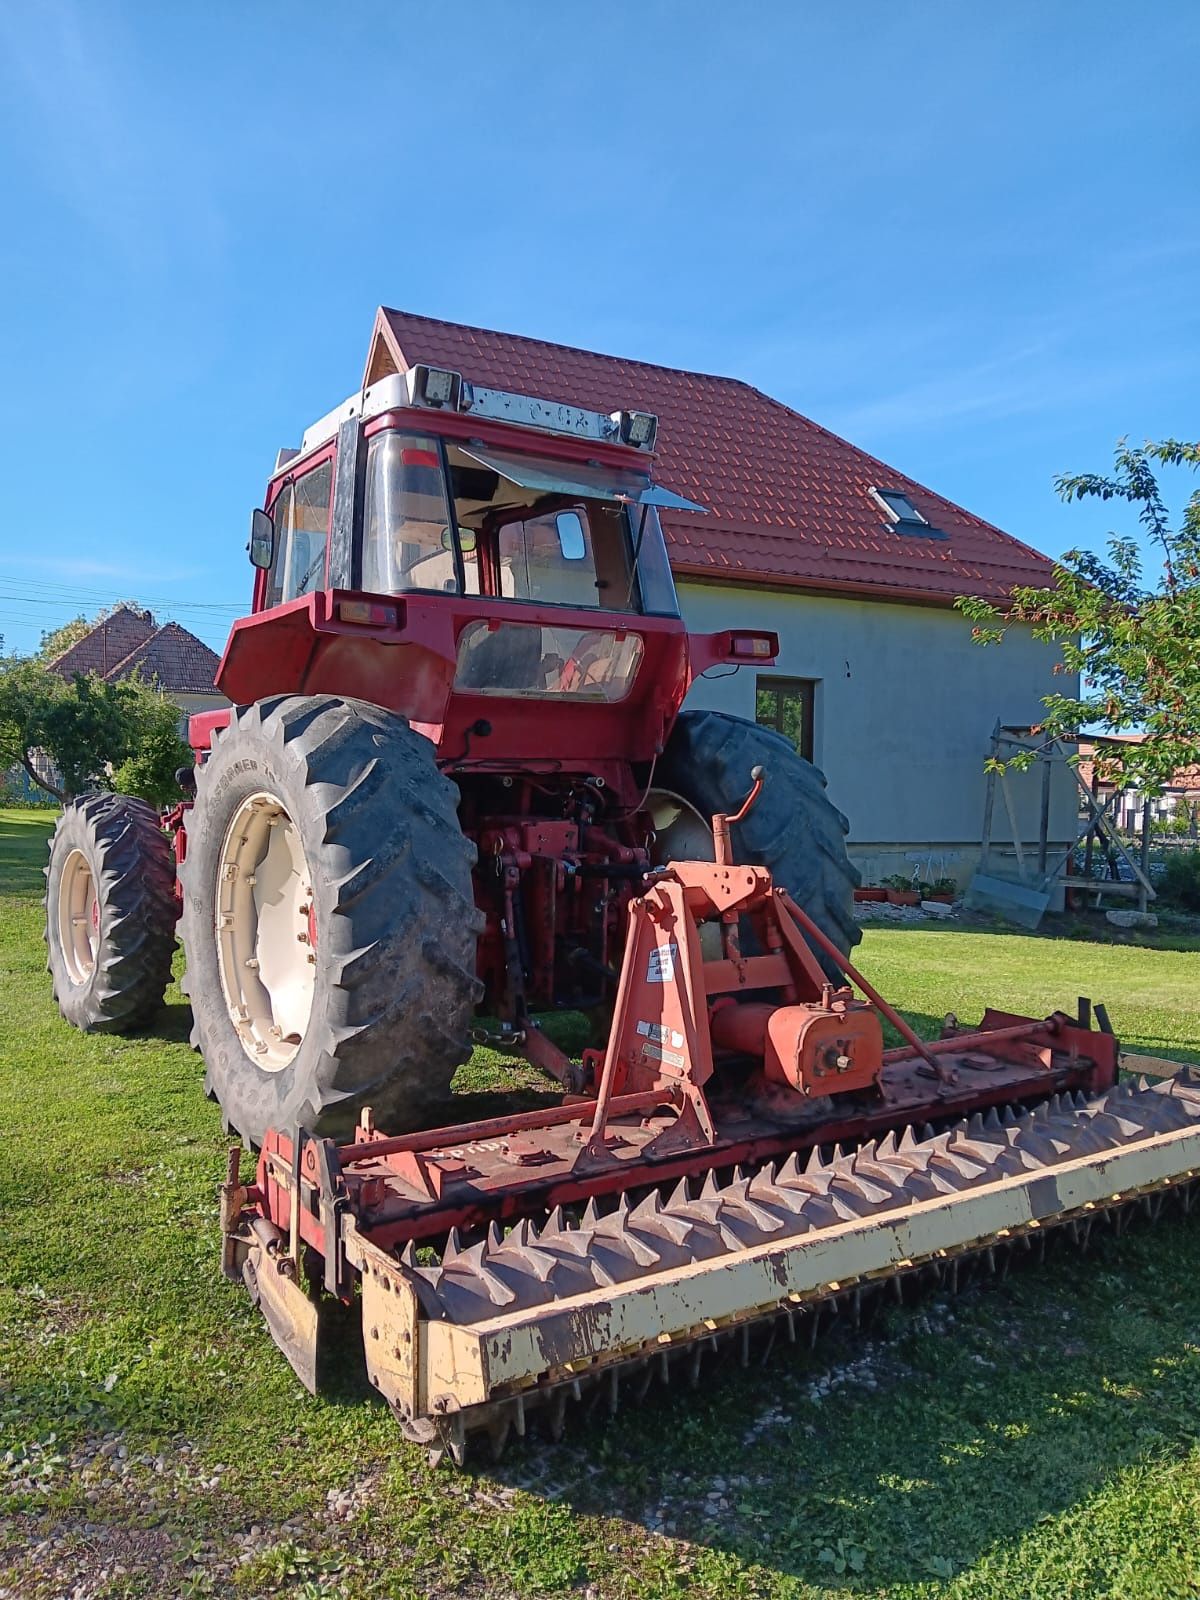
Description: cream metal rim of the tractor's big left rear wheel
216,794,317,1072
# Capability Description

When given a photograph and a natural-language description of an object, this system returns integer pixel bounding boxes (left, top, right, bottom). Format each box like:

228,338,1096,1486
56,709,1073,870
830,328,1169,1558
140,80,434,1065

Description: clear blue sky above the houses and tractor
0,0,1200,648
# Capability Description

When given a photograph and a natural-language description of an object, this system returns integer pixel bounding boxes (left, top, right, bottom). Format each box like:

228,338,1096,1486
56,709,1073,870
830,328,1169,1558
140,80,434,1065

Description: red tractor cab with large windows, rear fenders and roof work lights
209,366,776,789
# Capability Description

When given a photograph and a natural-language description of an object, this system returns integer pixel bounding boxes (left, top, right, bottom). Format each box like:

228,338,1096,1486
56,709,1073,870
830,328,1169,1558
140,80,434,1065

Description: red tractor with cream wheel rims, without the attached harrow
48,350,858,1144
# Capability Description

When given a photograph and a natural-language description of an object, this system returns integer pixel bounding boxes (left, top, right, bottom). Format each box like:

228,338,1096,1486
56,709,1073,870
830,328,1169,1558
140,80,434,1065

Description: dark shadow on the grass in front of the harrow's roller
475,1222,1200,1592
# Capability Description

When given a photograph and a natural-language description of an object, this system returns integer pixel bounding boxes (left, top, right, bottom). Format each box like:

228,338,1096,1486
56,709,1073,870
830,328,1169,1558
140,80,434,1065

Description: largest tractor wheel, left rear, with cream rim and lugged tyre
181,694,482,1144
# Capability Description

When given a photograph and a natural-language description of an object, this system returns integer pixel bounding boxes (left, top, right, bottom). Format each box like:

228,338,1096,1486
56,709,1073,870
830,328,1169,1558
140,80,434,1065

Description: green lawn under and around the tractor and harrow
0,813,1200,1600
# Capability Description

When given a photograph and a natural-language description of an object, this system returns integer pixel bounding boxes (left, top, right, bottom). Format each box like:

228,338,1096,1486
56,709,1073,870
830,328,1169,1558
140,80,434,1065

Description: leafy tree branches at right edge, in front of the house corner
955,438,1200,795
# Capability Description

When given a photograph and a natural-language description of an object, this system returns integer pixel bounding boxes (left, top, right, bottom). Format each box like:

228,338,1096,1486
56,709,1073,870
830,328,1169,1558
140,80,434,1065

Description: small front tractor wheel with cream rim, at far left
45,795,176,1034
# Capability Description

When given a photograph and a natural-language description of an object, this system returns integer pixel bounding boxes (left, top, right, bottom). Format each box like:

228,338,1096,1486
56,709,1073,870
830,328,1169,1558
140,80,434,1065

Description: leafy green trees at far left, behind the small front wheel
0,656,190,805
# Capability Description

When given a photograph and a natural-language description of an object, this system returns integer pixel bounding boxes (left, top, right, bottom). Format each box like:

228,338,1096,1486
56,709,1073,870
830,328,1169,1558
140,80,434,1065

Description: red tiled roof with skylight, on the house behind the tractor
368,307,1053,605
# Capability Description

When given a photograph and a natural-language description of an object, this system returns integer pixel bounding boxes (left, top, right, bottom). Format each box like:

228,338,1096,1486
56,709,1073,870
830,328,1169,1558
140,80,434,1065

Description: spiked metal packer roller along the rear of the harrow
376,1078,1200,1459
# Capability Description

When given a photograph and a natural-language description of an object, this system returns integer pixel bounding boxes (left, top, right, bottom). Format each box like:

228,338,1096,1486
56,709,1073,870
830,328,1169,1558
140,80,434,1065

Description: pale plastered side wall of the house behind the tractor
678,582,1075,882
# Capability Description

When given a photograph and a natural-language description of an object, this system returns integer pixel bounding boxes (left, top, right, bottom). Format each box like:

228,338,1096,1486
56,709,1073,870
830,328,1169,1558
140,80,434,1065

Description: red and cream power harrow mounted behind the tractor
222,774,1200,1464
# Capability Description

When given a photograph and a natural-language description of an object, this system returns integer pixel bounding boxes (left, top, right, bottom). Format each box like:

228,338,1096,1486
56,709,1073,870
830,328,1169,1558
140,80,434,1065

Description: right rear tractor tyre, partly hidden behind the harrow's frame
653,710,862,978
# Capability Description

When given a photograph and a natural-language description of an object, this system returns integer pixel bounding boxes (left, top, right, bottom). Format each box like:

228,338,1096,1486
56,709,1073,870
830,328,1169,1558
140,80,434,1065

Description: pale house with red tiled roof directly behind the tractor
356,309,1075,882
